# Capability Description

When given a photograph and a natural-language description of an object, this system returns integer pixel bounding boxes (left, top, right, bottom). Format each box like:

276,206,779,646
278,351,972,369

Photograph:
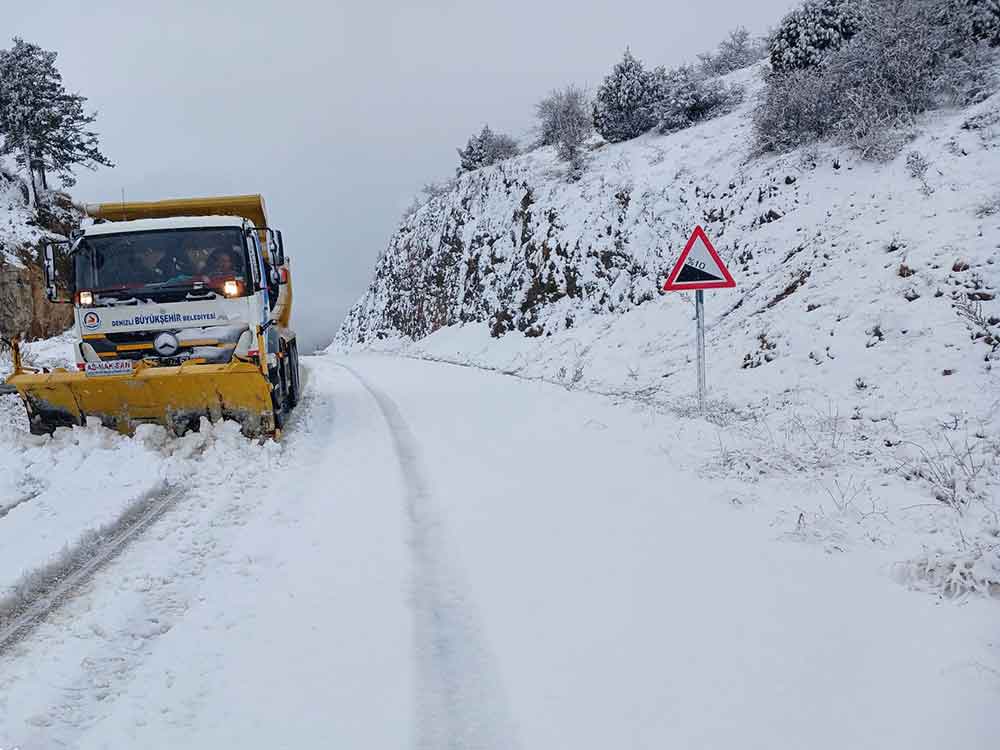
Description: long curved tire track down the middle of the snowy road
340,363,519,750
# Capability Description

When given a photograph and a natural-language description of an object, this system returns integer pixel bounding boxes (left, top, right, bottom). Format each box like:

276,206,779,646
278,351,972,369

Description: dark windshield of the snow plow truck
74,227,247,296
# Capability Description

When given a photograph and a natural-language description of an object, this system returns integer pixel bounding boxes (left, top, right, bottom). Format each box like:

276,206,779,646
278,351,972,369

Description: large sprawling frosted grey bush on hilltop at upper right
754,0,992,159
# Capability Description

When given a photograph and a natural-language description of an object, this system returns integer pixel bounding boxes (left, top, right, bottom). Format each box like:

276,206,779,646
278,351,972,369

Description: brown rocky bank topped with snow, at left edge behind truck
0,172,80,339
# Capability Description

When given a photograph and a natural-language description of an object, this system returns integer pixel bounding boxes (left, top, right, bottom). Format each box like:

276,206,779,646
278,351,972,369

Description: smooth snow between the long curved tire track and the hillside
346,358,1000,748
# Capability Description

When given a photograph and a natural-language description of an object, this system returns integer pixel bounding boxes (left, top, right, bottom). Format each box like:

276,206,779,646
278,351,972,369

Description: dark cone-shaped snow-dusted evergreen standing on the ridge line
594,49,657,143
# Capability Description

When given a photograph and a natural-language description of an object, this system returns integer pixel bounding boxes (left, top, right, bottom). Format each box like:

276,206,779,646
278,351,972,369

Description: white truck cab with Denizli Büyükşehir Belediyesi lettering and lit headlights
70,216,283,371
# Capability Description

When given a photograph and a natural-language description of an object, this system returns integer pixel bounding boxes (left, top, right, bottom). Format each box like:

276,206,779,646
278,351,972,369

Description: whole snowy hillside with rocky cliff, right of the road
335,64,1000,591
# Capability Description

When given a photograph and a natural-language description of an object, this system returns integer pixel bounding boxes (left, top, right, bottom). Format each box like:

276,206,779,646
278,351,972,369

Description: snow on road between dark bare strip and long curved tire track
0,356,412,750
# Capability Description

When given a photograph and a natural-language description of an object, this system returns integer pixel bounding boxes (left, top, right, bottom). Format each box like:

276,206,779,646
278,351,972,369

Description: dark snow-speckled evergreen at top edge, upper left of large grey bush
770,0,860,73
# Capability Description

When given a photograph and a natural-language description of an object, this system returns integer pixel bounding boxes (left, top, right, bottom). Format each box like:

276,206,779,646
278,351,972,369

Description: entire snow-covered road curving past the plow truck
0,356,1000,750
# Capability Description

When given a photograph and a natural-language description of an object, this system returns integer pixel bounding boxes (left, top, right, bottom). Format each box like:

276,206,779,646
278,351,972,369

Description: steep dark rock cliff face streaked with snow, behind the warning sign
338,71,788,345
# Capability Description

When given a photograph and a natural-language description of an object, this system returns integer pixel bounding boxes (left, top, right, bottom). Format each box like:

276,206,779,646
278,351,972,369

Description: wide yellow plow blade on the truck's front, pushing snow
7,362,275,436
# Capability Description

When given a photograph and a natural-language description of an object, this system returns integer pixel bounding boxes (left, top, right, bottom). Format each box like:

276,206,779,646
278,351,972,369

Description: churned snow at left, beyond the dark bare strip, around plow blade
0,332,282,640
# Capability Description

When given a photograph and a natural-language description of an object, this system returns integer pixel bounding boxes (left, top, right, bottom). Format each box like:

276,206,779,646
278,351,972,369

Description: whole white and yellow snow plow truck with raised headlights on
7,195,301,437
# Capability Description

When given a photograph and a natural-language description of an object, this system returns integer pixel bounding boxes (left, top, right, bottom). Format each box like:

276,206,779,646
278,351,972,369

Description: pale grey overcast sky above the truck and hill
9,0,796,349
